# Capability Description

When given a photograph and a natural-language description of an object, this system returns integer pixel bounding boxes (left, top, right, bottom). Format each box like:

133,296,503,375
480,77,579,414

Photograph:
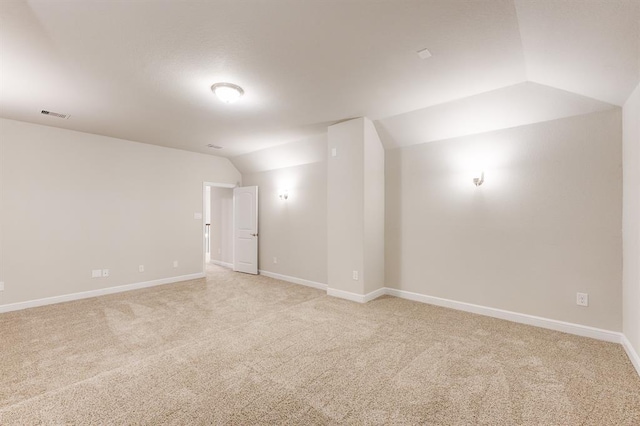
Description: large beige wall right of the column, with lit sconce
386,109,622,331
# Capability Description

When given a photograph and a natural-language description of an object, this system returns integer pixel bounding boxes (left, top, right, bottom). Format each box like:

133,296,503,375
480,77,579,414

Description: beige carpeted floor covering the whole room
0,266,640,426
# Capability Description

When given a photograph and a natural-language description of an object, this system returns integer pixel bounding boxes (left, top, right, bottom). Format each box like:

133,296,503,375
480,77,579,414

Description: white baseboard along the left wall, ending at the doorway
0,272,205,314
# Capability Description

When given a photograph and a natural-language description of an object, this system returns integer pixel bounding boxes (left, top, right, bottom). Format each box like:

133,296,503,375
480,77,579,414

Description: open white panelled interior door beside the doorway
233,186,258,274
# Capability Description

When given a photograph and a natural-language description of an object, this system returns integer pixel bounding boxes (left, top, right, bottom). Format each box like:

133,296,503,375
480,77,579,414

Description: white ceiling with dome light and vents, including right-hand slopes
0,0,640,156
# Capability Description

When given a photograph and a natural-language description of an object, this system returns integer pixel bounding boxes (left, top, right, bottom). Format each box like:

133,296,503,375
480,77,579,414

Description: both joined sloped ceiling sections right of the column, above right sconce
375,0,640,149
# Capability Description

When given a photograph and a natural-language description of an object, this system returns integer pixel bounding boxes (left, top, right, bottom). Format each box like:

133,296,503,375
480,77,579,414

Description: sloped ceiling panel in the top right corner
515,0,640,106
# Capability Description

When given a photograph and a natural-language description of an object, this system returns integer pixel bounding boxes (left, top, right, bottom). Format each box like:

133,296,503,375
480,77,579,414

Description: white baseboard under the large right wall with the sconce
386,288,622,343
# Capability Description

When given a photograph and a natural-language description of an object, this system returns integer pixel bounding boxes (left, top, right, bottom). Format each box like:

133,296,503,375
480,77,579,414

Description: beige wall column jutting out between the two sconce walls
327,117,385,295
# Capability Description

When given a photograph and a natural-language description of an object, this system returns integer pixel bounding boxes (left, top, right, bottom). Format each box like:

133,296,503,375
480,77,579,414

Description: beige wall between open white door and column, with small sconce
242,151,327,284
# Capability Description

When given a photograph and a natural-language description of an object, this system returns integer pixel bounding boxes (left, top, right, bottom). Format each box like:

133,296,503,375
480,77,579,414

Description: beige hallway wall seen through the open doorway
210,186,233,263
